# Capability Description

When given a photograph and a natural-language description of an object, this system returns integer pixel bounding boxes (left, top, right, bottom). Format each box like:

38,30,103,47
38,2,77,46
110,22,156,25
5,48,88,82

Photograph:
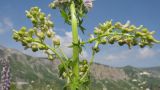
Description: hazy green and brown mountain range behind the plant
0,46,160,90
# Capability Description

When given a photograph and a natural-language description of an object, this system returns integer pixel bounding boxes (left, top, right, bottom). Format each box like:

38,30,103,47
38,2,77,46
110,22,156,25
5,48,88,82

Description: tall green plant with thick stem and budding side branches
13,0,160,90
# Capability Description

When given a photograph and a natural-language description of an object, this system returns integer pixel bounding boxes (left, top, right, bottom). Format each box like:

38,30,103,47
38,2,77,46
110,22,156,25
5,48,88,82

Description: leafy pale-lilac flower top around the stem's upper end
49,0,93,32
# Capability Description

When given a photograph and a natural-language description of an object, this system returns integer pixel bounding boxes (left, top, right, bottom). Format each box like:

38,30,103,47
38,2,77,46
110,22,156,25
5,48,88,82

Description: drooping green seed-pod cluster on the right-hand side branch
89,20,159,49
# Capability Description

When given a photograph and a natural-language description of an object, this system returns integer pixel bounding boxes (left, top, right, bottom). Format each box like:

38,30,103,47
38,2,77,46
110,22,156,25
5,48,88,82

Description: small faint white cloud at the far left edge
0,17,13,34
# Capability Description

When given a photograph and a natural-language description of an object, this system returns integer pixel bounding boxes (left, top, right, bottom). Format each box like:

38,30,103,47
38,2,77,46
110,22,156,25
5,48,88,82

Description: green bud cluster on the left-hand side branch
13,7,60,60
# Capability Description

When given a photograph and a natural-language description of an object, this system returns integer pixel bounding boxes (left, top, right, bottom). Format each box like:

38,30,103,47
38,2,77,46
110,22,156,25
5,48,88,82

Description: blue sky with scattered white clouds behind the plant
0,0,160,67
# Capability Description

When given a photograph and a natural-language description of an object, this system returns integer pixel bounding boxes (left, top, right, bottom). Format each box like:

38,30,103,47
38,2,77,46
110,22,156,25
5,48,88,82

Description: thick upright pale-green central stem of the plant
70,2,79,90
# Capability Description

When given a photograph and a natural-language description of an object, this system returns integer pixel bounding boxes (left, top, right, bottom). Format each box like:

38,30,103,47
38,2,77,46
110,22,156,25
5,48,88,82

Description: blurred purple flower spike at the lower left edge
0,58,10,90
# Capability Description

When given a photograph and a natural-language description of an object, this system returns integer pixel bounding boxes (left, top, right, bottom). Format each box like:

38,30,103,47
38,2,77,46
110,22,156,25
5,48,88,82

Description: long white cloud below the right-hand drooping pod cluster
105,47,158,61
